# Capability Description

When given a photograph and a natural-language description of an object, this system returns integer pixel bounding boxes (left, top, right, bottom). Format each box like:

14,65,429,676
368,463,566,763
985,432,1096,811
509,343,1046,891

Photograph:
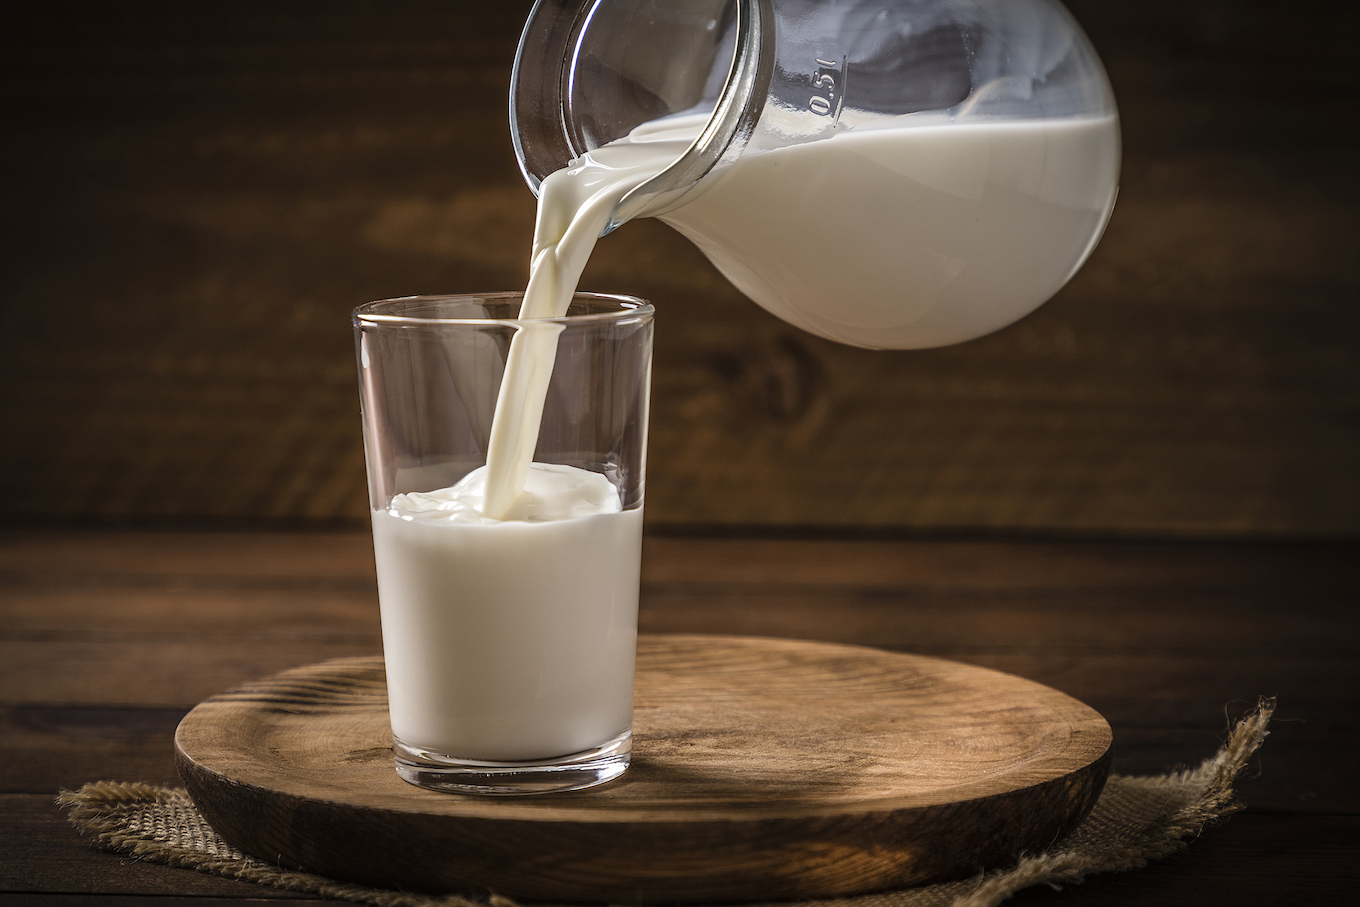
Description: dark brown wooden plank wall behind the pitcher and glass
0,0,1360,538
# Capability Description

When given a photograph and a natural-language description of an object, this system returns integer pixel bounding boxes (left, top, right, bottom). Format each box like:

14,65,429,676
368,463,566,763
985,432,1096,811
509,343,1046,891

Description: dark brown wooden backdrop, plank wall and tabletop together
0,0,1360,907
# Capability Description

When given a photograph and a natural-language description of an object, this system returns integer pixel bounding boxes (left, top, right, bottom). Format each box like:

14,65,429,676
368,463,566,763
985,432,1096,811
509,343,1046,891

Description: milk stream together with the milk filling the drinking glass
373,126,691,761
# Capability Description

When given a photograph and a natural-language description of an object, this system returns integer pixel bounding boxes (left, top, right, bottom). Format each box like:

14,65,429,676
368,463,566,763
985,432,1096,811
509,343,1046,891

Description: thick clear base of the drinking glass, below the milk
392,729,632,797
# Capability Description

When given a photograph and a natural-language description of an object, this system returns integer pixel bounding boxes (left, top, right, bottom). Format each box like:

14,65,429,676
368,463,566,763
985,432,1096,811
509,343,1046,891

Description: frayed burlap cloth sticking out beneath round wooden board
57,700,1274,907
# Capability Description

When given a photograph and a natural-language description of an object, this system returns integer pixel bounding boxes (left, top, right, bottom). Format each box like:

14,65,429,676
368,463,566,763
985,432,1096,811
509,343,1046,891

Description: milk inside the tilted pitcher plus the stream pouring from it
484,104,1119,518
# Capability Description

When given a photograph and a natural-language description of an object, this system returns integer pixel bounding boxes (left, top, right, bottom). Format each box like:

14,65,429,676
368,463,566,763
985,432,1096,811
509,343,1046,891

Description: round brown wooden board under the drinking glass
175,636,1111,903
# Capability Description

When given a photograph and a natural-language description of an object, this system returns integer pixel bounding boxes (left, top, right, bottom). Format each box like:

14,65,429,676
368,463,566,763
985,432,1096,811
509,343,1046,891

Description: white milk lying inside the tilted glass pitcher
661,114,1119,349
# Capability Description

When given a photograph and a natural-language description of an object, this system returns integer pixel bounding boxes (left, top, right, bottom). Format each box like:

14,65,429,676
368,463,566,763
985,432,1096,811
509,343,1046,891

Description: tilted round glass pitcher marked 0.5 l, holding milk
510,0,1119,348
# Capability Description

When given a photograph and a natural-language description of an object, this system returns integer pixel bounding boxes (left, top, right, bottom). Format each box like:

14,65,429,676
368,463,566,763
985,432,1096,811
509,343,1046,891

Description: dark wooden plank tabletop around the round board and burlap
0,530,1360,907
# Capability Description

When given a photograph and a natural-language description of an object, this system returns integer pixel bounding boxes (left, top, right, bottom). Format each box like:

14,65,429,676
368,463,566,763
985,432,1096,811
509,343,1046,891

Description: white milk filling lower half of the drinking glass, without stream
373,464,642,761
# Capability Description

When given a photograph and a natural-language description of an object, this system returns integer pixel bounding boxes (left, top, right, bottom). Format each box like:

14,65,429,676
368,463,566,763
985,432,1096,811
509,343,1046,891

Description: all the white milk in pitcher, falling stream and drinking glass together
374,108,1118,760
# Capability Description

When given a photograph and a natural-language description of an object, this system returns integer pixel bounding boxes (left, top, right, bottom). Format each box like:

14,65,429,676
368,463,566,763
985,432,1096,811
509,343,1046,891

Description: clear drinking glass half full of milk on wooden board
354,294,653,794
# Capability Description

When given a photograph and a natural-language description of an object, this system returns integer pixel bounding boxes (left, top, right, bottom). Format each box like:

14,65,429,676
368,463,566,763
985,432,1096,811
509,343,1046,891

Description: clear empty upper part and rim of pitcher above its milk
510,0,1115,214
